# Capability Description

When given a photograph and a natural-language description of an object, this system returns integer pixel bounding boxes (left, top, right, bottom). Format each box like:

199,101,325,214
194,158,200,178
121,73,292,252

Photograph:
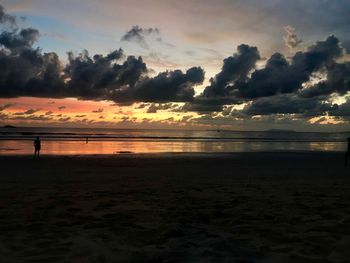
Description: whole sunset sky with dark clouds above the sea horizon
0,0,350,131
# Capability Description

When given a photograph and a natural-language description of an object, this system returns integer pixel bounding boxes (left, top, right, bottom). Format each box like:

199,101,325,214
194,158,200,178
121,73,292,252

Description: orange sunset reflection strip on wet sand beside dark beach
0,140,346,155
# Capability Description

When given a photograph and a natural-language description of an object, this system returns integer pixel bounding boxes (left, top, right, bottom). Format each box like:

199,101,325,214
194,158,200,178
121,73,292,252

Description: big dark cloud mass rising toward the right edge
183,36,350,115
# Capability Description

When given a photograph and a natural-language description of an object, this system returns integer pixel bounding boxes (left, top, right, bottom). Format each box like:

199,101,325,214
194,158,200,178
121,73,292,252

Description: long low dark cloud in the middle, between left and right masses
66,52,198,104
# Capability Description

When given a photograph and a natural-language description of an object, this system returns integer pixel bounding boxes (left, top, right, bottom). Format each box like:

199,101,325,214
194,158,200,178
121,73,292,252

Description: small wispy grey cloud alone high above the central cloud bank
121,26,161,49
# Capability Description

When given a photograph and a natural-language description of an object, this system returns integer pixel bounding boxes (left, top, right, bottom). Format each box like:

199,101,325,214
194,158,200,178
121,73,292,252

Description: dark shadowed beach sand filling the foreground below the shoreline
0,153,350,263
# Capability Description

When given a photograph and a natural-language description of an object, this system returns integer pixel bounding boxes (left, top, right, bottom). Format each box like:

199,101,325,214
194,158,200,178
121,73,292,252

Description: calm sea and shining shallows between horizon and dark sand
0,128,350,155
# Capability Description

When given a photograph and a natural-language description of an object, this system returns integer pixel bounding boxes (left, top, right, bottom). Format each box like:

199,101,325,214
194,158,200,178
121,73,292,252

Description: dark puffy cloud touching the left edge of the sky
0,28,64,97
